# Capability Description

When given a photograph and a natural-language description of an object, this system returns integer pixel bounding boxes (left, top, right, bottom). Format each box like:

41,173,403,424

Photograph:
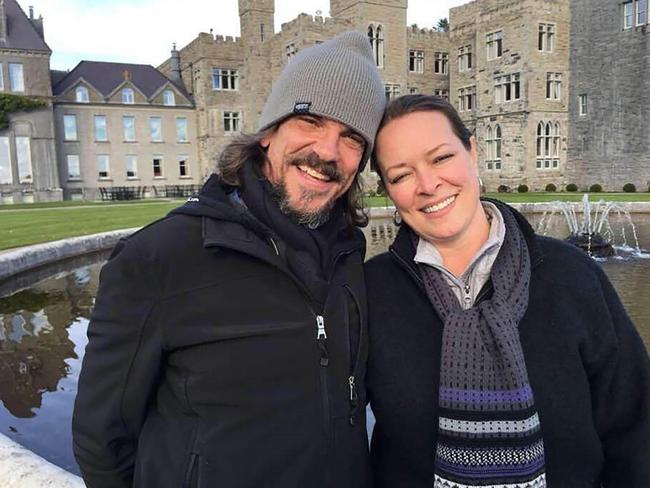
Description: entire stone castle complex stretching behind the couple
0,0,650,201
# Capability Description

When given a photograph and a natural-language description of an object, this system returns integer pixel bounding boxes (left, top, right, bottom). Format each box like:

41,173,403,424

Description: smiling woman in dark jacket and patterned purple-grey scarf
366,95,650,488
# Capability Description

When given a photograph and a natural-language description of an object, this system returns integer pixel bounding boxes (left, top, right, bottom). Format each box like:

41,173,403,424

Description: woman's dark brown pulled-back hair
370,94,472,177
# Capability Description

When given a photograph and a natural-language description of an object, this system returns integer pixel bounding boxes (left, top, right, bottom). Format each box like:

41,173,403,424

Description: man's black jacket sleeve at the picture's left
72,234,162,488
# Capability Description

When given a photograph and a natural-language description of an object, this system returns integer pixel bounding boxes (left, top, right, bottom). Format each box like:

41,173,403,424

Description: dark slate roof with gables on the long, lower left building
53,61,192,102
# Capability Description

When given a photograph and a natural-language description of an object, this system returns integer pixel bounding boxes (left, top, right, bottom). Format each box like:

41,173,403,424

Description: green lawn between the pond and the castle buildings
0,193,650,250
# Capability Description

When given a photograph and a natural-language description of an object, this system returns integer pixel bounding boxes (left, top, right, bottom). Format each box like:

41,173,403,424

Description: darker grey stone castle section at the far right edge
569,0,650,191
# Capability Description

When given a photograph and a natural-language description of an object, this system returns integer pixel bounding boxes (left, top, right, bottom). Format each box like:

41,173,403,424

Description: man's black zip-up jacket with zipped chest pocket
73,178,369,488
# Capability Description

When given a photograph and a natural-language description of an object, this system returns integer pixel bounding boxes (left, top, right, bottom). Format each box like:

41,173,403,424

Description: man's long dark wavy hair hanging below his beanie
217,130,368,227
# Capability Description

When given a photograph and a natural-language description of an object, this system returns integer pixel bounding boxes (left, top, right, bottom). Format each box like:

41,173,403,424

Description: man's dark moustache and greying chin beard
271,152,342,229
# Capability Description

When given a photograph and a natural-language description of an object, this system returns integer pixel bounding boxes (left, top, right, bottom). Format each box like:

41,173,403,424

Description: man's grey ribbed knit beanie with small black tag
259,31,386,169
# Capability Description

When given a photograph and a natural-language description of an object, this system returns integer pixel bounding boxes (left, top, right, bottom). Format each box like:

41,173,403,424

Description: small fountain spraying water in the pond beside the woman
537,193,641,258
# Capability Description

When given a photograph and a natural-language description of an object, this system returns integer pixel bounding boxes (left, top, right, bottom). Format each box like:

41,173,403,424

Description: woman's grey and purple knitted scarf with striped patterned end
420,206,546,488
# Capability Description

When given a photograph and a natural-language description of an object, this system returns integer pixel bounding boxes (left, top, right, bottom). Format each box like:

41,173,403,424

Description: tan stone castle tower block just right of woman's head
449,0,570,191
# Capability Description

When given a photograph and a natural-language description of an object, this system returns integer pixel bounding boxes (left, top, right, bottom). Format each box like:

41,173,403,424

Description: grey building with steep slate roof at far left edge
0,0,62,203
